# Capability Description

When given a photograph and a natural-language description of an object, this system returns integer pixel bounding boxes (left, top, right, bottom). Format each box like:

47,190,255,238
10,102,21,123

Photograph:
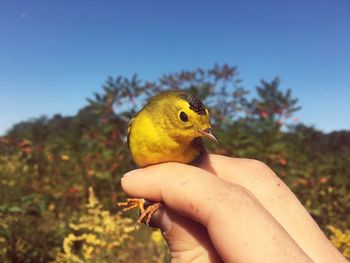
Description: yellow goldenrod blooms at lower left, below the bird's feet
56,187,166,262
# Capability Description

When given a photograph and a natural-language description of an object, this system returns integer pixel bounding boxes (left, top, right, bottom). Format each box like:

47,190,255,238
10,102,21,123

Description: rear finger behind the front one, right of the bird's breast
201,155,340,262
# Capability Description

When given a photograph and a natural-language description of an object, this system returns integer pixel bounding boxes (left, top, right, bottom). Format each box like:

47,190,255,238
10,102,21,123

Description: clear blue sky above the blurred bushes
0,0,350,134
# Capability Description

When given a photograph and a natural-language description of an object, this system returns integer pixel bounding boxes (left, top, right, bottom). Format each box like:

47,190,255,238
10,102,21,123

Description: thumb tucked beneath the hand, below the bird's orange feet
152,206,222,262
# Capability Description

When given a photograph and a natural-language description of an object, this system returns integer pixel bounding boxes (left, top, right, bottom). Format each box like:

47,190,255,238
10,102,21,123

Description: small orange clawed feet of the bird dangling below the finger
117,198,161,226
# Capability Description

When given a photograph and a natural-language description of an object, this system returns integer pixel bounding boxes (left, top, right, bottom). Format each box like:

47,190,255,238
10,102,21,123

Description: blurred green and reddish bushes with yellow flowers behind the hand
0,65,350,262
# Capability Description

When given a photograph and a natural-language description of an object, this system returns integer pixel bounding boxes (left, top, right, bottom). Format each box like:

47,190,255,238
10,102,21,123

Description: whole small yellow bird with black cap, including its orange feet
117,90,218,225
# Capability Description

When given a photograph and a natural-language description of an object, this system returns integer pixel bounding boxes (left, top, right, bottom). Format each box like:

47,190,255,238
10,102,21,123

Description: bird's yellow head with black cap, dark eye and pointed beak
161,92,218,142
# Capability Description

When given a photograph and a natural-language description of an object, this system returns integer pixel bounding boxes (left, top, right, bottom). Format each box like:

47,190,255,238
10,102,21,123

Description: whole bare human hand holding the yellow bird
122,155,348,262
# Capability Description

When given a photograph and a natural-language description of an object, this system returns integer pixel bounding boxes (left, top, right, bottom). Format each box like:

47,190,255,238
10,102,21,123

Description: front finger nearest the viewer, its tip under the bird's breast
122,163,308,262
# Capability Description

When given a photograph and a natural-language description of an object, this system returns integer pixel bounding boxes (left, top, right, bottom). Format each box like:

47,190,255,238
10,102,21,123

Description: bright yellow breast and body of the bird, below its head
128,111,201,167
